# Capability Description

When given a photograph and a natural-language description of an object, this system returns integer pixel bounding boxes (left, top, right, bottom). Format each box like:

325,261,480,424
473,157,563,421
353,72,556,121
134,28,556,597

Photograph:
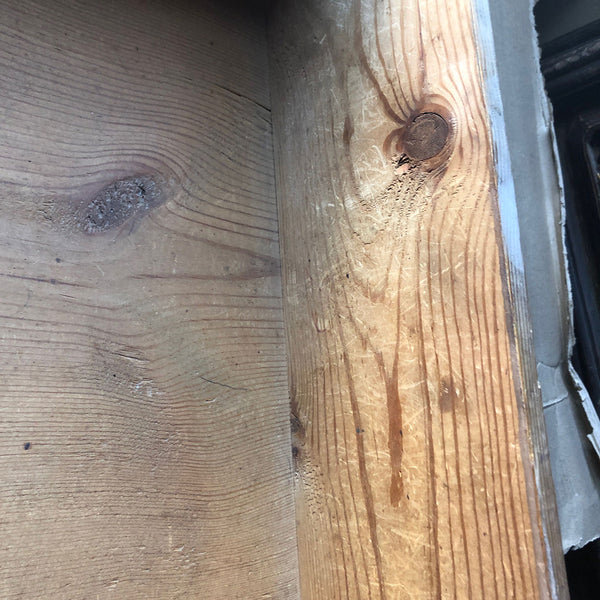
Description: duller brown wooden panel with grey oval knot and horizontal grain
0,0,298,600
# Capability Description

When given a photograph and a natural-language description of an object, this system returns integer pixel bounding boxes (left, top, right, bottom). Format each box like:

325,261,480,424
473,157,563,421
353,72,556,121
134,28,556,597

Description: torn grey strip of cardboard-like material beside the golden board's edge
486,0,600,552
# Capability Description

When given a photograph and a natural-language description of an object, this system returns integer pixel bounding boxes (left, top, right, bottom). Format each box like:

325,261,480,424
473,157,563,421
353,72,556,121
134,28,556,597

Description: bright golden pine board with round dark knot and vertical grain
269,0,552,600
